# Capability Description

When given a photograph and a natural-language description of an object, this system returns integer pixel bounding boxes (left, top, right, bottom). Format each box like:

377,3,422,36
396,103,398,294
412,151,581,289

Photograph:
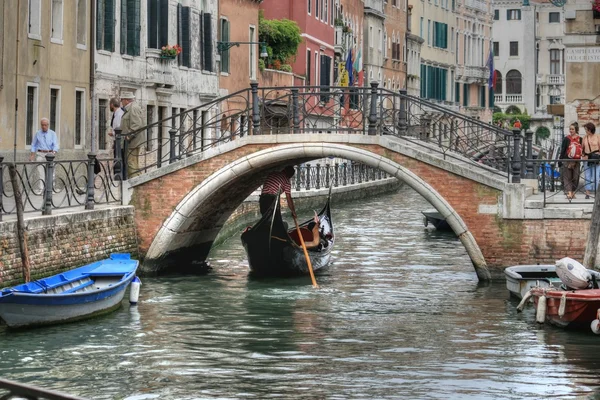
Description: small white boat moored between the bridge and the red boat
504,264,561,299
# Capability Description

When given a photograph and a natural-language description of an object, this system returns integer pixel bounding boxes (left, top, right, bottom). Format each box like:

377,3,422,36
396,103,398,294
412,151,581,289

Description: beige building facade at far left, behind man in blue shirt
0,0,93,161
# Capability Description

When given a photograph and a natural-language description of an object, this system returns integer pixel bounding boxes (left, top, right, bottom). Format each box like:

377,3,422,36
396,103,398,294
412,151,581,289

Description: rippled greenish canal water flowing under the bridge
0,189,600,400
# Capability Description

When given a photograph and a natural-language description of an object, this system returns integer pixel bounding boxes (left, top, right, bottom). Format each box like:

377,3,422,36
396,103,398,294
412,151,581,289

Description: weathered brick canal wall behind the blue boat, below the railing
0,207,138,287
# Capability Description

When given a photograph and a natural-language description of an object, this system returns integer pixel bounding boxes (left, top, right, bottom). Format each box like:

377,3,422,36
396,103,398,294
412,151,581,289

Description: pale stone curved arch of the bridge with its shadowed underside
144,142,491,280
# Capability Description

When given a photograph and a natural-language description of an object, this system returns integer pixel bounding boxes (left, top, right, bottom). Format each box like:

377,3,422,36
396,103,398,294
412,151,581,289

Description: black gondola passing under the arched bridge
241,191,335,277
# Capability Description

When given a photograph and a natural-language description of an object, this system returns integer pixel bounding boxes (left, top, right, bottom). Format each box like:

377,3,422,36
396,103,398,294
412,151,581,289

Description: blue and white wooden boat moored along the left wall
0,254,139,328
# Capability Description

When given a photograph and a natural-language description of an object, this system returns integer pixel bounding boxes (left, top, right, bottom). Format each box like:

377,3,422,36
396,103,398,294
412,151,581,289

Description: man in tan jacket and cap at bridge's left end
121,91,146,179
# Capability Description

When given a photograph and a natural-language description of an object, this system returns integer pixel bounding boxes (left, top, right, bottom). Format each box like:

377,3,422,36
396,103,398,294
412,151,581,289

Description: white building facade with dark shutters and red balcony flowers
94,0,219,157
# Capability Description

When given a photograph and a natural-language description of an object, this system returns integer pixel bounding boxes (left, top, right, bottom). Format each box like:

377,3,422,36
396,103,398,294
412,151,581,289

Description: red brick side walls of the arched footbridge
131,144,589,279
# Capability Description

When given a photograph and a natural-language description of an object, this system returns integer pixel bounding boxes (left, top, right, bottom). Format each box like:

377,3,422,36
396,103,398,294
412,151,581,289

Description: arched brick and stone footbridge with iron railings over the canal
124,85,582,280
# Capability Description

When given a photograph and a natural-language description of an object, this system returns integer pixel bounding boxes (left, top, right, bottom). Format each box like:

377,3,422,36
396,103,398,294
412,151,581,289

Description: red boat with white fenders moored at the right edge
530,287,600,329
